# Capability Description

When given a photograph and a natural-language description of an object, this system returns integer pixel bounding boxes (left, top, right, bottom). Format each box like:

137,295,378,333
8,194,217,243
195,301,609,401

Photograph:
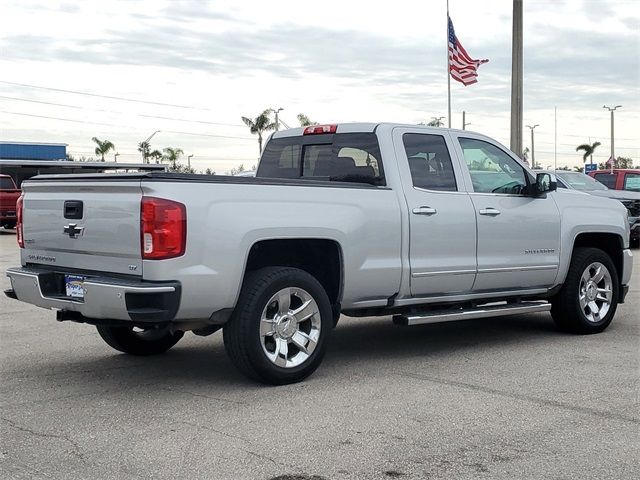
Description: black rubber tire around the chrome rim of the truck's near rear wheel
223,267,333,385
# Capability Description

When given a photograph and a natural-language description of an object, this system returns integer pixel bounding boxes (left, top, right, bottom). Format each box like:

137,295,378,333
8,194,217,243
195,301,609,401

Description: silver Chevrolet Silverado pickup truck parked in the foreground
6,123,632,384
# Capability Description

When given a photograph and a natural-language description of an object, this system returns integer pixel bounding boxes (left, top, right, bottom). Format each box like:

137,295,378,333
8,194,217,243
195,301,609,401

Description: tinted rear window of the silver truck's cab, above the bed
256,133,386,186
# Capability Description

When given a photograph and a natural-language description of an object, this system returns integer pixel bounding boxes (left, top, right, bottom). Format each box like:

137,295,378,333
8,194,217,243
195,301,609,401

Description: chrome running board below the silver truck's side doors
393,301,551,326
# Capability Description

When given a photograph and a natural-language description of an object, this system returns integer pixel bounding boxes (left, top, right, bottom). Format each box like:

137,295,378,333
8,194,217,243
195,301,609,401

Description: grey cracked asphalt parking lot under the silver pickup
0,231,640,480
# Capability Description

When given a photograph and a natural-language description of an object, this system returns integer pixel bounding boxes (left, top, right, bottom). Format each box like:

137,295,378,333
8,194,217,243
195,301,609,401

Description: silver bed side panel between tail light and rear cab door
142,182,401,319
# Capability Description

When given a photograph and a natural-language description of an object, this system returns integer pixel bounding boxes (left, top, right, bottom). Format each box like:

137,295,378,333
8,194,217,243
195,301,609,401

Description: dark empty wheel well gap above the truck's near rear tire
246,238,342,305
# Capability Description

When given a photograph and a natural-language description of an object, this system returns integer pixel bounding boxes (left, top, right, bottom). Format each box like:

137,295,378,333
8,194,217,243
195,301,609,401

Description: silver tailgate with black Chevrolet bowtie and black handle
22,179,142,276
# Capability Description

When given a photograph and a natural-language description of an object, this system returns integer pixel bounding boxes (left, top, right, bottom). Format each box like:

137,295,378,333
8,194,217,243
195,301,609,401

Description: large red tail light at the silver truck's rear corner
140,197,187,260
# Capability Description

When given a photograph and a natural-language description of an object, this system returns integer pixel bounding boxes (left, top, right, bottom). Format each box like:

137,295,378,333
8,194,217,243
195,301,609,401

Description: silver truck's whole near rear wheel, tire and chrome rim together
224,267,333,385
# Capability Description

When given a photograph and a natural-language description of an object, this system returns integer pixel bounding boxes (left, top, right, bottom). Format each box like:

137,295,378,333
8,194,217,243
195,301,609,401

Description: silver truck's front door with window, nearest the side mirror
454,134,560,292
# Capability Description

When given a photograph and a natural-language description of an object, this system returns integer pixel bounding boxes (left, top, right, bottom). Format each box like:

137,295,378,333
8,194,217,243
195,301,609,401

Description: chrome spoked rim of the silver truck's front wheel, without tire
578,262,613,323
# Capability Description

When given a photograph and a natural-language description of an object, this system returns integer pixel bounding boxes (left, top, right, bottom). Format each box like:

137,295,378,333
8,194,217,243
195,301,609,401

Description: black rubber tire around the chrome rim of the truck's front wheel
551,247,620,335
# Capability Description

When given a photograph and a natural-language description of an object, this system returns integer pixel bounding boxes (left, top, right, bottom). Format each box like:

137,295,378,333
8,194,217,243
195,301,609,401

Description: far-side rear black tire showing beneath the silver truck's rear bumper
96,325,184,356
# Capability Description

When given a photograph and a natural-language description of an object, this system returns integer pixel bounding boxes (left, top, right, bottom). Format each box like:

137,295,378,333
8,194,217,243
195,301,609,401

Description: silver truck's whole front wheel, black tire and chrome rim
551,248,620,334
